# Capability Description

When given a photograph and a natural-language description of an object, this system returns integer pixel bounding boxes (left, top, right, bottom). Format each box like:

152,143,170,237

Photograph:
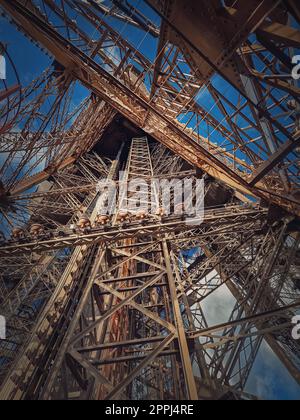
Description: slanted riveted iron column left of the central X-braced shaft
0,146,123,400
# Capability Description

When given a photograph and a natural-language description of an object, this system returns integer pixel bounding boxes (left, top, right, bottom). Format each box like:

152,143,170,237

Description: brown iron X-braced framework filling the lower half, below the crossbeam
0,138,300,399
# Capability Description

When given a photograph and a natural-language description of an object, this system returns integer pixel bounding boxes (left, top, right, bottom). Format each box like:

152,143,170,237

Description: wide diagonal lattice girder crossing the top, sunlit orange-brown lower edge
2,1,299,212
